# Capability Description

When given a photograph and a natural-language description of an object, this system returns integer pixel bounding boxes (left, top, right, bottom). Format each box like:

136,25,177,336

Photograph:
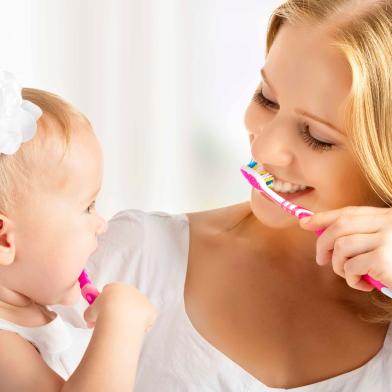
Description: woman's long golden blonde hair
267,0,392,322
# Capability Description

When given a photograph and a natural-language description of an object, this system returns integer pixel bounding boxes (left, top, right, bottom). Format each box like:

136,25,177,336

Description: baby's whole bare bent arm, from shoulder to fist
0,283,155,392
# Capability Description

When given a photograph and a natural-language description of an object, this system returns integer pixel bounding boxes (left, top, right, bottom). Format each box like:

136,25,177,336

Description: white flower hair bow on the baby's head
0,70,42,155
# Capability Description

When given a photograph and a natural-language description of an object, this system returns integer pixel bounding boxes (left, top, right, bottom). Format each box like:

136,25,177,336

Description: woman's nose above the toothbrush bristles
249,117,293,166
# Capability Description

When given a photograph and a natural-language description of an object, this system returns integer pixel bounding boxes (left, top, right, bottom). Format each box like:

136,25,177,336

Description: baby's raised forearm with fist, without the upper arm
64,283,155,392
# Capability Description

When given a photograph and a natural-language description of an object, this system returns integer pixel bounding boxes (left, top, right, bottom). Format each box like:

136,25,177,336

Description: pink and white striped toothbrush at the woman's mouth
241,160,392,298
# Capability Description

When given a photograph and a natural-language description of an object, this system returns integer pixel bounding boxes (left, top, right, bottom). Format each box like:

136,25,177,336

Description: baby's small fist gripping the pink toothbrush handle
84,283,156,332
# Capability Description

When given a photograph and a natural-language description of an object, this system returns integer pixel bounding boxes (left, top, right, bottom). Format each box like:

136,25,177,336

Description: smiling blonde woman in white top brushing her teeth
59,0,392,392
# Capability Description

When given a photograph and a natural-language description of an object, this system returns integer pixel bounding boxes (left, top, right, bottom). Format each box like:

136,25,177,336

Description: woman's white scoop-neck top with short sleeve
54,210,392,392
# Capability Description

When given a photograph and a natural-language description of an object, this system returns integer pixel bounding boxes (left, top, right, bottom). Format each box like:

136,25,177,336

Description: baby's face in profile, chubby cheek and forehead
9,119,106,305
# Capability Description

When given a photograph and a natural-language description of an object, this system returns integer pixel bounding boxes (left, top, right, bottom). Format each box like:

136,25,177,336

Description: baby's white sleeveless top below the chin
0,315,92,380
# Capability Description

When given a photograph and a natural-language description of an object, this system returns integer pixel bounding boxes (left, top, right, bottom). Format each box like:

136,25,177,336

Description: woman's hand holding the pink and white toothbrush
300,207,392,291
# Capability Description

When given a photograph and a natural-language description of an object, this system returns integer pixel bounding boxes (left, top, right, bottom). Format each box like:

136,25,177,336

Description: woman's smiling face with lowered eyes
245,23,382,228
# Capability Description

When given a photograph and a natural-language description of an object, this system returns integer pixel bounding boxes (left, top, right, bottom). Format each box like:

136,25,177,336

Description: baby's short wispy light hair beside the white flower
0,88,90,214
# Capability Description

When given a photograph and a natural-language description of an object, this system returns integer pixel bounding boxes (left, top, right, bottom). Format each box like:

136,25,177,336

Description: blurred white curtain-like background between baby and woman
0,0,282,218
